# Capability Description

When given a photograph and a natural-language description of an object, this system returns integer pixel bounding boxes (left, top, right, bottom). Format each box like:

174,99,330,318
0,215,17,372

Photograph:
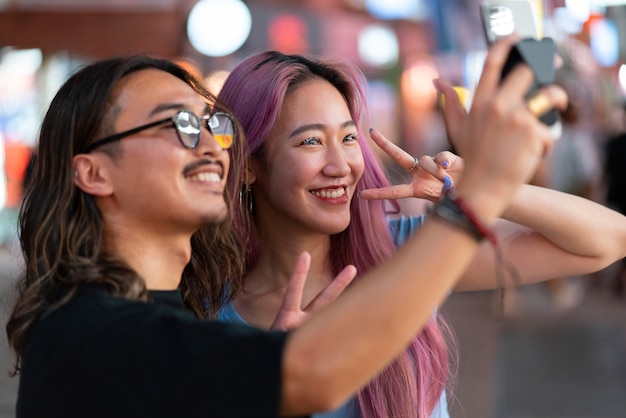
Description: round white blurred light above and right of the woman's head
358,25,399,68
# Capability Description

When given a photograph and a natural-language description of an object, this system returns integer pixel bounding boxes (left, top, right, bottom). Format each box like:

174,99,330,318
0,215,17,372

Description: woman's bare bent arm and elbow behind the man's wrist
455,185,626,291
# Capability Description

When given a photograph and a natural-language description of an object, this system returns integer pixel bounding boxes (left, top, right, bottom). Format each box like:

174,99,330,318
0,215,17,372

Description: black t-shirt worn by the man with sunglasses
17,286,287,418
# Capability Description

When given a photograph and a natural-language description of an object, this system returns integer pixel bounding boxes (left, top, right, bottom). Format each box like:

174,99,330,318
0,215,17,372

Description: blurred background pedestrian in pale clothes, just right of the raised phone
504,39,609,314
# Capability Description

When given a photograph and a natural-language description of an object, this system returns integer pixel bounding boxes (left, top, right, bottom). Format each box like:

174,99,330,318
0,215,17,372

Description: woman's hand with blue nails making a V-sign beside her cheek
360,129,463,202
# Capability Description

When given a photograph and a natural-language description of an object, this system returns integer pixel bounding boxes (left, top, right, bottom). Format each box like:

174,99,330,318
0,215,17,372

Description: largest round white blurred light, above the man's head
187,0,252,57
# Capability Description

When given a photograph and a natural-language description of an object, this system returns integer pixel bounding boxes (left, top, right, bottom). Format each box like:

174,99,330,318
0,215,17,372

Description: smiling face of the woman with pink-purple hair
252,78,364,235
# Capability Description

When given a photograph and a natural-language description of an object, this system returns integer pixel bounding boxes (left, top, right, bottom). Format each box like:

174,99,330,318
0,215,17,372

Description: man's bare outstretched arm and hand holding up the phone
282,39,567,415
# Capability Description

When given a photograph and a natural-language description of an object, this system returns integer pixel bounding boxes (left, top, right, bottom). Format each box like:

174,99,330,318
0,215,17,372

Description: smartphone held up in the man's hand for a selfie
480,0,562,139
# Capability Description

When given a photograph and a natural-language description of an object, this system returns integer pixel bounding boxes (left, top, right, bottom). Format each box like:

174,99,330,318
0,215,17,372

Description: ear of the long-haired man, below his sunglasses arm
72,154,113,196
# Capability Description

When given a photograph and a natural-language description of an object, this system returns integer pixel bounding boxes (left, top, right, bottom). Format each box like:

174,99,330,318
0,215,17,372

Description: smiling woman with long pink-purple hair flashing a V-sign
213,51,626,418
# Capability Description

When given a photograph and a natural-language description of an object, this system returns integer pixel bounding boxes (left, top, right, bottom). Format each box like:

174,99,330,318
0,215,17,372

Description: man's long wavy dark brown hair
6,55,242,372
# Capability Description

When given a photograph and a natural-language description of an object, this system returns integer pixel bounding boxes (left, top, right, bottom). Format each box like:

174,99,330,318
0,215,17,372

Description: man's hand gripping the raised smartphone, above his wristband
435,36,567,224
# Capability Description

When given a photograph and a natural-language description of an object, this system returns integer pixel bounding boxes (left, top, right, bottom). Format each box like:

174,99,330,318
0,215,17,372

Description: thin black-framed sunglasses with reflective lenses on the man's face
86,110,235,152
